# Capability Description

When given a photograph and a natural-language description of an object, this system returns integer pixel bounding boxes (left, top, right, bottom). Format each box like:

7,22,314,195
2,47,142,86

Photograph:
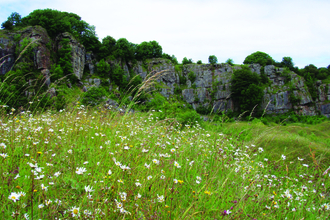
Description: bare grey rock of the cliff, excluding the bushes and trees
0,26,330,117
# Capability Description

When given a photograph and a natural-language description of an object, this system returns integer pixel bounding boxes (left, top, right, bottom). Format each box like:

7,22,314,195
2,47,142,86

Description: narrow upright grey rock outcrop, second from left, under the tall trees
55,33,86,80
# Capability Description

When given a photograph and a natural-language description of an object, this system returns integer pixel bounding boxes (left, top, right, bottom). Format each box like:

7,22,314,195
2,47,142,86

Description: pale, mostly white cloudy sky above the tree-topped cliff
0,0,330,68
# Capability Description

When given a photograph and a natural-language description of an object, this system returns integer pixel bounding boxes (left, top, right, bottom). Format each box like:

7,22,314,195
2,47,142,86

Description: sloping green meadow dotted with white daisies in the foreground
0,105,330,219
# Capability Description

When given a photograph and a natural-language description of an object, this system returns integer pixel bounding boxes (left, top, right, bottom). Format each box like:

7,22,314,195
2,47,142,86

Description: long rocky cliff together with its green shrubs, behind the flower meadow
0,10,330,117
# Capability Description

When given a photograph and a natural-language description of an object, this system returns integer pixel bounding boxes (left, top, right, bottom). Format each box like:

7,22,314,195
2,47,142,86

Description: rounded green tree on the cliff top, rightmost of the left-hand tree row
135,41,163,60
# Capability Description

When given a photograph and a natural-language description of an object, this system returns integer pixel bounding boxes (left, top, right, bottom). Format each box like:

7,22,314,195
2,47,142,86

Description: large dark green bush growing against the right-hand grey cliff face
231,67,263,113
